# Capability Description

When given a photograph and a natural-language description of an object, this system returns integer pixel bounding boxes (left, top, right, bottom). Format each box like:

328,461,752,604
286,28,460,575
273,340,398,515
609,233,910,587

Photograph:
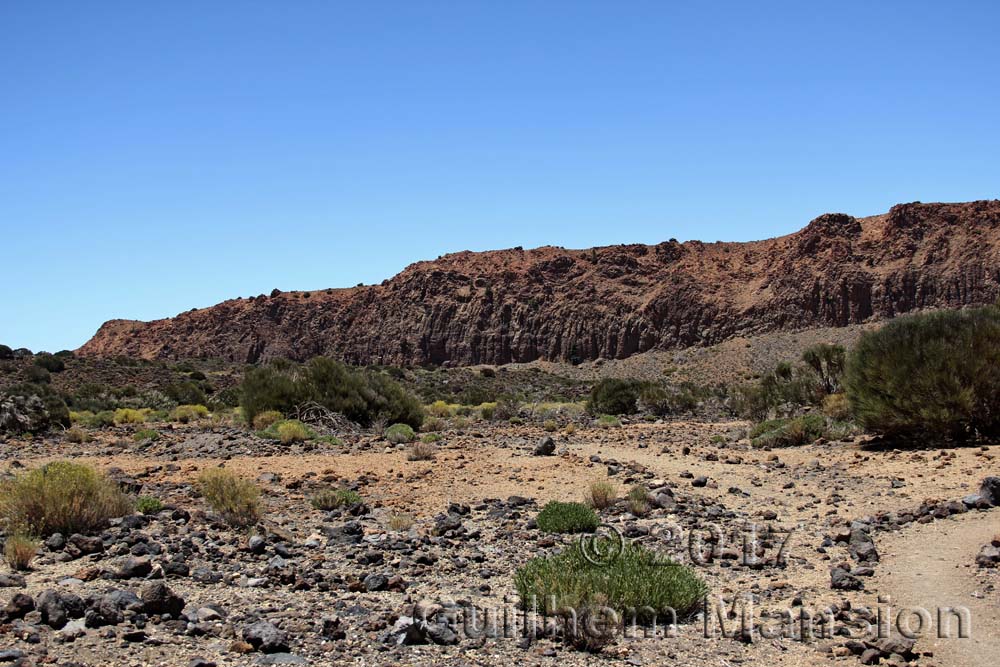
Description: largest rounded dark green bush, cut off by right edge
845,306,1000,440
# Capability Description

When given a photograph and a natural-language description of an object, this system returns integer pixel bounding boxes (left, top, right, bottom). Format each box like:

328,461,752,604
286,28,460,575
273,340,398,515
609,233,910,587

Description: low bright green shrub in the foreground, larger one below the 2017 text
514,538,708,623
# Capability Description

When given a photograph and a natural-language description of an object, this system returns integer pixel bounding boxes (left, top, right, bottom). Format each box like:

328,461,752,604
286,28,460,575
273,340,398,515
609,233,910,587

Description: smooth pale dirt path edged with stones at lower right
876,510,1000,667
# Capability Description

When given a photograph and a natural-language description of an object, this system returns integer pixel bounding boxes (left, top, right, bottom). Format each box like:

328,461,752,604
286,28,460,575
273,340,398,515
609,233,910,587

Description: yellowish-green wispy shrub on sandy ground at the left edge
0,461,131,536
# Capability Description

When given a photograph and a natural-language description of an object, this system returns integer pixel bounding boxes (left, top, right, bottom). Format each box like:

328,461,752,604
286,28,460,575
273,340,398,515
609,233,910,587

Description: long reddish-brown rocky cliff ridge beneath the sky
79,200,1000,364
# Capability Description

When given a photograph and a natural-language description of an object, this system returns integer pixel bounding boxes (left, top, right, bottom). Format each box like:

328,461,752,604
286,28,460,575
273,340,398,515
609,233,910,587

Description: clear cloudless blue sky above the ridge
0,0,1000,351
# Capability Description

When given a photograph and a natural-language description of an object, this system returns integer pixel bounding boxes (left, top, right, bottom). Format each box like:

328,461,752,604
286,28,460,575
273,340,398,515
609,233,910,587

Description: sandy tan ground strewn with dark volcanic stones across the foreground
0,340,1000,666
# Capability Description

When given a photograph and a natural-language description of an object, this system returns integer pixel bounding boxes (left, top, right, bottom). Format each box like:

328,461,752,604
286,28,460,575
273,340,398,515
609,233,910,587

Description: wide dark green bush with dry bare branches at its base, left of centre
240,357,424,428
